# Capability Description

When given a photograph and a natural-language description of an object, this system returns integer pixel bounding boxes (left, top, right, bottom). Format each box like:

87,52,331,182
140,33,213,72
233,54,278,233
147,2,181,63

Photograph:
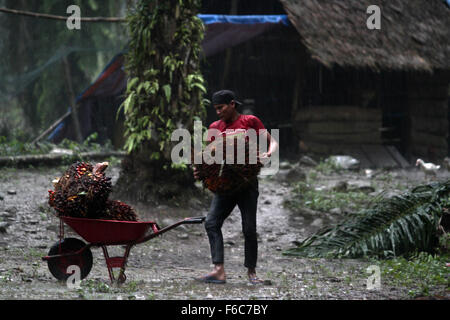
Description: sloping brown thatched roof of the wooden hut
280,0,450,71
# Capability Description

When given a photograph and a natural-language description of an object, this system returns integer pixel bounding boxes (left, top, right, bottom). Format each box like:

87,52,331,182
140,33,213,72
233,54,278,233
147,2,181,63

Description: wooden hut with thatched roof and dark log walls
281,0,450,165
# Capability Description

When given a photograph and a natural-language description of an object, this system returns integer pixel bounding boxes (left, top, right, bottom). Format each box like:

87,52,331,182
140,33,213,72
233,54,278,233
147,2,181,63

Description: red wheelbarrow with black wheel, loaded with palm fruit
42,217,205,283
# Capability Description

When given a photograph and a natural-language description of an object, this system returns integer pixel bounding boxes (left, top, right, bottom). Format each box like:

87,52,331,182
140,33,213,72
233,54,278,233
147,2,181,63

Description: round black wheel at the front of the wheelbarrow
47,238,92,281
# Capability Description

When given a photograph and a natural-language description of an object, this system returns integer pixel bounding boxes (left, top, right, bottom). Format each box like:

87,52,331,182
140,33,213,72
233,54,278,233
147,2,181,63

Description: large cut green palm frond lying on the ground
283,180,450,258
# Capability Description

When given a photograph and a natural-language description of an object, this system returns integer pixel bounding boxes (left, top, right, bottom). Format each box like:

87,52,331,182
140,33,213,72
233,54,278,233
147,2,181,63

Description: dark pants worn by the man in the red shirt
205,184,259,268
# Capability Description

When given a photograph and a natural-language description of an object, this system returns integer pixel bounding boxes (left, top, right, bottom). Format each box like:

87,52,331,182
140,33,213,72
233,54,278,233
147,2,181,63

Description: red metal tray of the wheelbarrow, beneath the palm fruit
60,217,158,245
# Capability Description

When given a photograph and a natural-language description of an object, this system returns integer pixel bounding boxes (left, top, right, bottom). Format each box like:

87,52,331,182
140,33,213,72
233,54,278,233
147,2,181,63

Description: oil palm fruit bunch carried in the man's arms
196,132,263,194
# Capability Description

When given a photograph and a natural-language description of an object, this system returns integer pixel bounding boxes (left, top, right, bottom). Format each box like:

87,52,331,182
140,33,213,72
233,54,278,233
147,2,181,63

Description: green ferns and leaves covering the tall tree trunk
121,0,207,163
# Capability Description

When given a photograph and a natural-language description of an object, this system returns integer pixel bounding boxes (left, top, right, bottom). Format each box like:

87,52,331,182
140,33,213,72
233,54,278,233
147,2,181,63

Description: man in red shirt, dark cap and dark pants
194,90,278,284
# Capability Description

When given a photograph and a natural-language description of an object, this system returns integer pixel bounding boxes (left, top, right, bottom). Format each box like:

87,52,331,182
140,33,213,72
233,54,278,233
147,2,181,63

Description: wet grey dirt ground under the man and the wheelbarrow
0,160,448,300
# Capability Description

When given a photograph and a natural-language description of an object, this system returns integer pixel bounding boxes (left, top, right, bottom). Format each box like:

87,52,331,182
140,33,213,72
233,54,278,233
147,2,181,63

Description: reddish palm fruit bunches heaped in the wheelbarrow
48,162,137,221
